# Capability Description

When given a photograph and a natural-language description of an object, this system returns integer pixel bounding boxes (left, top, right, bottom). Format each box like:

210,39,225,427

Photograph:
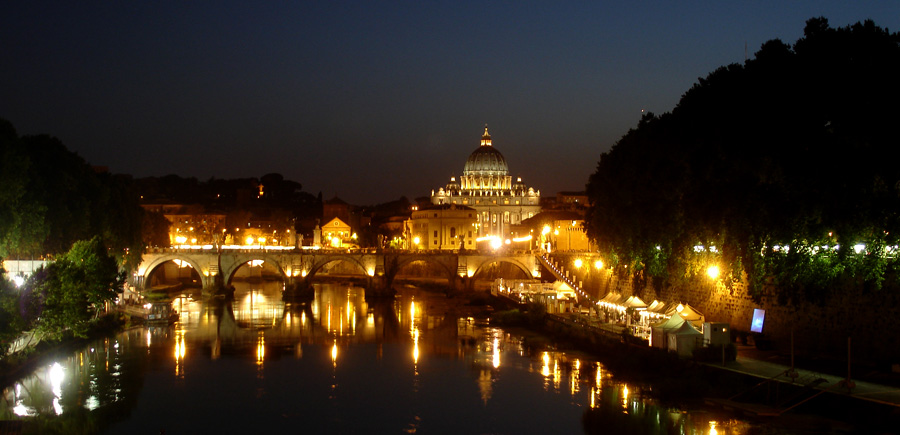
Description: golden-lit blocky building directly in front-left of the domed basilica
406,204,477,250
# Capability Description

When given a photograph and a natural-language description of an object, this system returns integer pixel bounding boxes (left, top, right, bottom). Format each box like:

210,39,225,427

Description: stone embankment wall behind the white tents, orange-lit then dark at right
552,253,900,369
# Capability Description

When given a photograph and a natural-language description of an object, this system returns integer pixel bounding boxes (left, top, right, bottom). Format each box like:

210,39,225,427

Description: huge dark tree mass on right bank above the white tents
587,18,900,303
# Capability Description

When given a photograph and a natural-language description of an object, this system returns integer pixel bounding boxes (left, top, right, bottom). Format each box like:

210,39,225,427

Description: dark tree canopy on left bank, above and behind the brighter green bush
0,119,145,267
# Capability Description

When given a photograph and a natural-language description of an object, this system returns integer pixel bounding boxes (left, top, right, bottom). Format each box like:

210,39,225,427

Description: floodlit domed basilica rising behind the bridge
431,125,541,239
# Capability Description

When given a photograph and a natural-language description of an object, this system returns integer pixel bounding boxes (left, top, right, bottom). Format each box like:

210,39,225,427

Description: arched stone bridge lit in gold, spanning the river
131,249,540,289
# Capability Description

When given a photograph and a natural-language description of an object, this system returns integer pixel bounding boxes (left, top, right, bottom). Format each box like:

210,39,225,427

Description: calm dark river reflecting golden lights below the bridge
0,282,800,435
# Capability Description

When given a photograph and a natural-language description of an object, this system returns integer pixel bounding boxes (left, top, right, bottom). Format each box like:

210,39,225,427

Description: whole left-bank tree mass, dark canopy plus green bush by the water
0,119,146,354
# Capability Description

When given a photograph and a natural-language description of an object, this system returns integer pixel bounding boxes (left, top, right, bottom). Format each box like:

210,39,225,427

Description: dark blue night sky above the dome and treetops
0,0,900,205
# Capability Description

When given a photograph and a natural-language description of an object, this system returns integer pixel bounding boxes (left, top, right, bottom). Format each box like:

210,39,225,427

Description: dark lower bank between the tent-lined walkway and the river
506,308,900,433
